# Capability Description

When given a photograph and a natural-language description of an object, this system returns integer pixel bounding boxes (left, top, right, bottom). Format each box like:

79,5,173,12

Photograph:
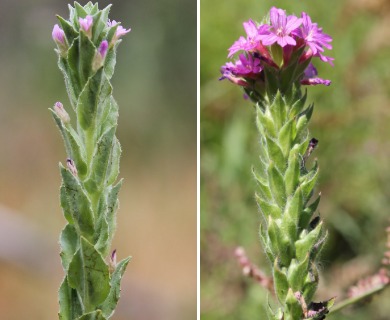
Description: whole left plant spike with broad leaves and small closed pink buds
51,2,130,320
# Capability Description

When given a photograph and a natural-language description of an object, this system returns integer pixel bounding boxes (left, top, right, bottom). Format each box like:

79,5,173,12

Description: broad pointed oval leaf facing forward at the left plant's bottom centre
68,237,110,312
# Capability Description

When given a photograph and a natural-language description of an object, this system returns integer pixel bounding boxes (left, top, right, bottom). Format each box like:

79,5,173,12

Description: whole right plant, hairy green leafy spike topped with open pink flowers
220,7,334,320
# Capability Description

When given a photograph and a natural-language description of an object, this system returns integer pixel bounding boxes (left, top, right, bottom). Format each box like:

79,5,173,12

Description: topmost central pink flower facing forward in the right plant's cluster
261,7,302,48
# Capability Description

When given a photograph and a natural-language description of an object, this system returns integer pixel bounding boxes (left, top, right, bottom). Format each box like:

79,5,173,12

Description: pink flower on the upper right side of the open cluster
292,12,332,55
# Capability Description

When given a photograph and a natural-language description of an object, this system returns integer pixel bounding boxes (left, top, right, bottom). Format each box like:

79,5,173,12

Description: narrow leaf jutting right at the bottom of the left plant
100,257,131,318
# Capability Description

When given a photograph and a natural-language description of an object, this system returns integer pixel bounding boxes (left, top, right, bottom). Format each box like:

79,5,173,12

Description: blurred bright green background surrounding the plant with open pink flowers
200,0,390,320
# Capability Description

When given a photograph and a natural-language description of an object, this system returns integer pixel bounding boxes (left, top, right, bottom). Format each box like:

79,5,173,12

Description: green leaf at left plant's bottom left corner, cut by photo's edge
58,277,83,320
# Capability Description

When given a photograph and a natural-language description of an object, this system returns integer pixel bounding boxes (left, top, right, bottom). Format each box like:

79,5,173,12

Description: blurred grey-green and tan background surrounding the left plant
0,0,197,320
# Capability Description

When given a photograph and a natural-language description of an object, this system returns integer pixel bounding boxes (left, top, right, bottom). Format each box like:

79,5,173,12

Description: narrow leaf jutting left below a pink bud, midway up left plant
49,109,87,178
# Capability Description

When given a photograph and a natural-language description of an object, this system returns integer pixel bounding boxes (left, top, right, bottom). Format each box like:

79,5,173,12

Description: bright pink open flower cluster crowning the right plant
220,7,334,88
